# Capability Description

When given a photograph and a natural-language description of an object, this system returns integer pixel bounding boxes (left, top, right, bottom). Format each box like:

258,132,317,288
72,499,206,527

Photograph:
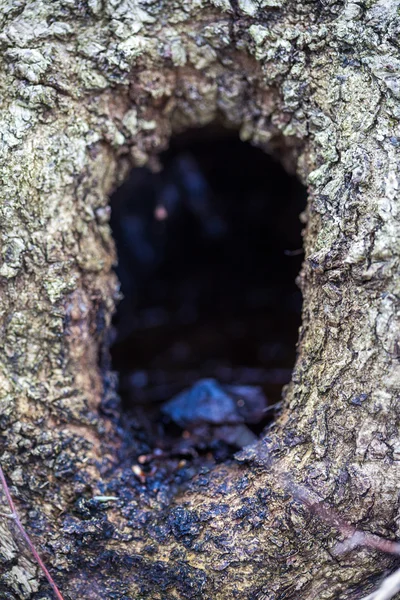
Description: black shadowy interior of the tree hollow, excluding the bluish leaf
111,128,306,460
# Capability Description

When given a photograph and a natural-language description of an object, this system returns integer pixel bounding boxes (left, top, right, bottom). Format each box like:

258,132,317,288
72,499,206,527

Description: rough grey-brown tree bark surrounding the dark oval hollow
0,0,400,600
